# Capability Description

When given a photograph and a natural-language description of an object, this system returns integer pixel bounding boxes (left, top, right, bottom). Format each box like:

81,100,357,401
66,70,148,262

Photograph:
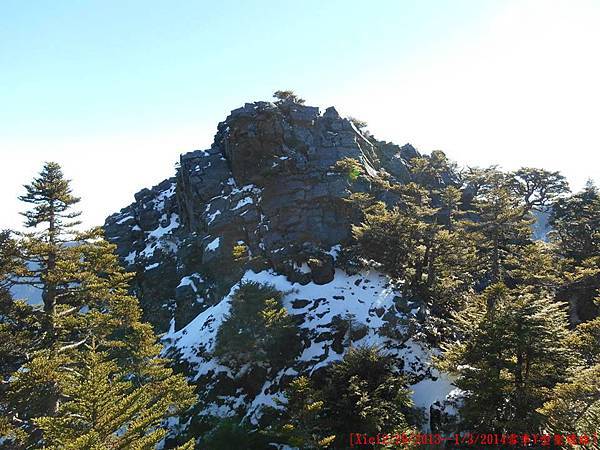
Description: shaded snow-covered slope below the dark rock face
164,262,454,428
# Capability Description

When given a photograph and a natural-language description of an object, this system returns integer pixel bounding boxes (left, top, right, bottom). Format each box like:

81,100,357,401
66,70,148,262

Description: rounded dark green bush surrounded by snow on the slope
214,282,301,372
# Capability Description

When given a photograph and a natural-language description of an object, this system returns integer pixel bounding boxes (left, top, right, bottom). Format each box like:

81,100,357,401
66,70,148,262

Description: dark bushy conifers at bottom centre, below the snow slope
280,347,412,449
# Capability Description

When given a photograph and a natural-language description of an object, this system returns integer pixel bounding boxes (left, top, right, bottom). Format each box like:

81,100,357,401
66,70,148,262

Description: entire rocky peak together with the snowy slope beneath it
105,97,460,428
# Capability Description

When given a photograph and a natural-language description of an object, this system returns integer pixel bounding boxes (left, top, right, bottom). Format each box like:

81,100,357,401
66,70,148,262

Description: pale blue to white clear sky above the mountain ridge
0,0,600,228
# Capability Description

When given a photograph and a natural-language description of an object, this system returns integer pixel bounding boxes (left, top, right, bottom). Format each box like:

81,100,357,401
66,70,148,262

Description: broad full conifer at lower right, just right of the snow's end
439,284,569,433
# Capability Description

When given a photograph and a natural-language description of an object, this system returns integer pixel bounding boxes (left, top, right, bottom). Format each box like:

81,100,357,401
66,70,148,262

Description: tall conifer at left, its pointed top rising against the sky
2,163,193,448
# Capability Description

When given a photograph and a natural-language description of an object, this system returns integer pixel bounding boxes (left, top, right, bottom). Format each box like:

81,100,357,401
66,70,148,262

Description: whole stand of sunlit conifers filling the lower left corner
0,163,194,449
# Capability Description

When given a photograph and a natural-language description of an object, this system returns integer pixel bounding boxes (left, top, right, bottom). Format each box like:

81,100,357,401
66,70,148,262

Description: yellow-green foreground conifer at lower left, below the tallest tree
31,344,192,450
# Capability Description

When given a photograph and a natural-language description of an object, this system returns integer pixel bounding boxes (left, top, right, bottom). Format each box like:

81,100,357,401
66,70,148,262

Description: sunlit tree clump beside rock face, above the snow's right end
352,183,476,311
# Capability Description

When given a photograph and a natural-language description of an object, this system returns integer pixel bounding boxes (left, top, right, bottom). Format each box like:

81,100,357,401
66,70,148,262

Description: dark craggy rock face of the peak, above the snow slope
105,101,419,331
